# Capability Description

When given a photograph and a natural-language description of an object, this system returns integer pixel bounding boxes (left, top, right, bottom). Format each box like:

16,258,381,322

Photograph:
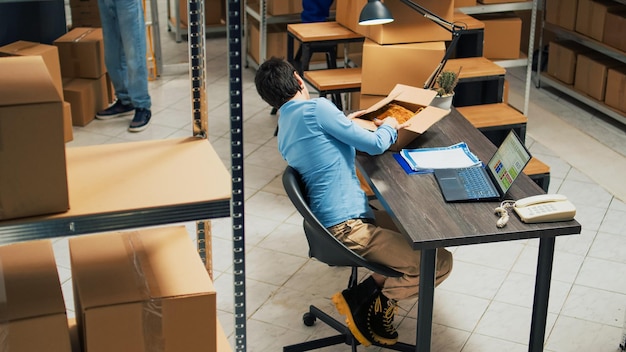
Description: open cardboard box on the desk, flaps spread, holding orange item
354,84,450,152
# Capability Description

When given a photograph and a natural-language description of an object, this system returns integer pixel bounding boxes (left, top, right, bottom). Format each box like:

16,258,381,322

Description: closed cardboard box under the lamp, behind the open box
361,39,446,96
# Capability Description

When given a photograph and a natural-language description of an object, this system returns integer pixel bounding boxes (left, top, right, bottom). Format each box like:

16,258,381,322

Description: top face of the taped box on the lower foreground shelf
69,226,215,310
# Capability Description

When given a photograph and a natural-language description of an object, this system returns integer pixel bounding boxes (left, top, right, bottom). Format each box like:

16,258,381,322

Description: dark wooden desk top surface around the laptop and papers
357,109,581,249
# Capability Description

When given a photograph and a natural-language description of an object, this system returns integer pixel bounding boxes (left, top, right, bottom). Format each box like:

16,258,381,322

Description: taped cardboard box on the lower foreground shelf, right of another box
69,226,217,352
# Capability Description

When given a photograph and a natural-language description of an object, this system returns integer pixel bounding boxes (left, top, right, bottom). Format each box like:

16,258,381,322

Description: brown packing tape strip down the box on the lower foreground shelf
125,231,165,352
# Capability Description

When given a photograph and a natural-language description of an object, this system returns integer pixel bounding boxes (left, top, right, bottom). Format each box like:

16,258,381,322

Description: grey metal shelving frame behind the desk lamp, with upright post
458,0,539,115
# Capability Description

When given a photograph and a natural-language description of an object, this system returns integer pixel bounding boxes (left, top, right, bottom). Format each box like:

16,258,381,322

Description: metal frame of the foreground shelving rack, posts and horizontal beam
0,0,247,351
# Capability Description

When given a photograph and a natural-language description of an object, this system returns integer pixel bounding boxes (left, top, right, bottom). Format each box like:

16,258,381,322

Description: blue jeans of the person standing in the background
98,0,152,109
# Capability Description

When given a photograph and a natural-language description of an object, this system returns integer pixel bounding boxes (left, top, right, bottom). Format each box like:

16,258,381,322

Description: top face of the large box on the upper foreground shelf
0,56,62,106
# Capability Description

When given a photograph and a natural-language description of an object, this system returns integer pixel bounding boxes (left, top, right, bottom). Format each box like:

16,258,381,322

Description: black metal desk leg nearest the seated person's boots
415,249,437,352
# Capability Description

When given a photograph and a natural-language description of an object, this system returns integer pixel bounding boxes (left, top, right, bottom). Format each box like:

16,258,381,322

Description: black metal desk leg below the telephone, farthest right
528,237,554,352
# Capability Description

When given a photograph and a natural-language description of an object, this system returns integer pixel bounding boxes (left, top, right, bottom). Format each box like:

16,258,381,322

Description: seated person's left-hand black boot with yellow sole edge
332,276,378,346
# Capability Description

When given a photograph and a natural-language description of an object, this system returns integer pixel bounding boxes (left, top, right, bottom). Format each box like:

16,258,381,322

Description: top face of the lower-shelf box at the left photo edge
0,240,65,322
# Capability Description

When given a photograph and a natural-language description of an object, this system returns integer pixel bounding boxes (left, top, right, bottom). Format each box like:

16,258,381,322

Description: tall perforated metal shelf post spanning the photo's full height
226,0,247,352
